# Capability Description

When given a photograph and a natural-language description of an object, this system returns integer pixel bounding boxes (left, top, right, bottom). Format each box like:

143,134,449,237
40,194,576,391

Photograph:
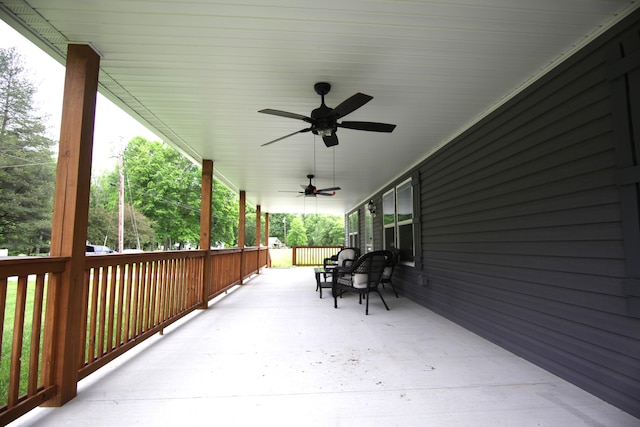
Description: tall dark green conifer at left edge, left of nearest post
0,48,55,254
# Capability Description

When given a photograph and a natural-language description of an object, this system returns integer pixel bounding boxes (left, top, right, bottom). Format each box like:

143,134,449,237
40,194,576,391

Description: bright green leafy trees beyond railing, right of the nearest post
88,137,240,249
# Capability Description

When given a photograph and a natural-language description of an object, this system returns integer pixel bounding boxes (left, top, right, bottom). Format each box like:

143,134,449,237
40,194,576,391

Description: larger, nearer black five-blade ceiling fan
258,82,396,147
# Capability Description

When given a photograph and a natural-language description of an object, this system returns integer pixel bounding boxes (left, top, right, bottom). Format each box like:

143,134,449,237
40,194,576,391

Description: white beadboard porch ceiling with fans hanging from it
0,0,639,214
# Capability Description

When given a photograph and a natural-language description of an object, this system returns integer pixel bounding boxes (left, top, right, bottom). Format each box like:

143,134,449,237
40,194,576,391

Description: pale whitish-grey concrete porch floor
10,268,640,427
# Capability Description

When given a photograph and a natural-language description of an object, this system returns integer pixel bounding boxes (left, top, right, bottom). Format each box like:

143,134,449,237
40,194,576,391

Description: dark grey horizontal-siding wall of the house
363,11,640,417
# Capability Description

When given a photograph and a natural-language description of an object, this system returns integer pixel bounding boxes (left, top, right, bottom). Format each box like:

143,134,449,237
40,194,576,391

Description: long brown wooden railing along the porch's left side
0,247,269,425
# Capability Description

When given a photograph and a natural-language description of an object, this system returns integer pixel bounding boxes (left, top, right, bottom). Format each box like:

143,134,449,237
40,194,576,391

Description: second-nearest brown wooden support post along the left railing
200,160,213,309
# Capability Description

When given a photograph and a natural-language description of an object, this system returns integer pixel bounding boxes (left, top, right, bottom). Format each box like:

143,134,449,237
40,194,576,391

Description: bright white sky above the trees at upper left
0,20,162,176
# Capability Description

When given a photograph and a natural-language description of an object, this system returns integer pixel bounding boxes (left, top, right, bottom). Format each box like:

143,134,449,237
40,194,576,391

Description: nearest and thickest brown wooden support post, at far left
43,44,100,406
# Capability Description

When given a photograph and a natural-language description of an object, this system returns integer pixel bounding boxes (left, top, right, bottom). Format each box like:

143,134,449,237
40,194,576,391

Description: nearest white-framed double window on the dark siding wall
382,179,415,265
